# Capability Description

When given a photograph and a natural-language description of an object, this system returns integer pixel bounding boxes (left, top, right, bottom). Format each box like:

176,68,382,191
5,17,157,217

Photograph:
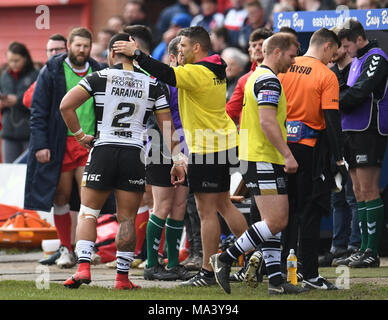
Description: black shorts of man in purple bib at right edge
344,131,387,169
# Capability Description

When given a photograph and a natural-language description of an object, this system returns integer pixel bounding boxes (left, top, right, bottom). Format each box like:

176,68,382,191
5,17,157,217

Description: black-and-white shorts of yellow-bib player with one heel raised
241,161,288,196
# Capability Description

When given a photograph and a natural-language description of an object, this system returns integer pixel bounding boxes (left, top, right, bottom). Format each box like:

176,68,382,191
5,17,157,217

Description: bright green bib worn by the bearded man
63,61,96,136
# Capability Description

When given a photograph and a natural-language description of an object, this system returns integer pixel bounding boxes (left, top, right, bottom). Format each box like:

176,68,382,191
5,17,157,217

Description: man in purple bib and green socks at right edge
338,19,388,268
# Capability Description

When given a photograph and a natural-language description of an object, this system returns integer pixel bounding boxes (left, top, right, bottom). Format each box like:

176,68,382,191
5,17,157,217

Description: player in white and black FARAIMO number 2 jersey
60,33,185,289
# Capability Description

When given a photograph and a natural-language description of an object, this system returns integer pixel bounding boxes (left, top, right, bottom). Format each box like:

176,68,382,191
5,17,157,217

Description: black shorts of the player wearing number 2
82,145,145,192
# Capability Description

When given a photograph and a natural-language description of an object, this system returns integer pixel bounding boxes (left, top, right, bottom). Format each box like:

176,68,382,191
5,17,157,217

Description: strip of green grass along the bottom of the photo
0,267,388,301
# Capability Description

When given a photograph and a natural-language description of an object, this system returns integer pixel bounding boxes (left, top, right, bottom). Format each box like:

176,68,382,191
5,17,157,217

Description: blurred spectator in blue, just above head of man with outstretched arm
157,0,200,34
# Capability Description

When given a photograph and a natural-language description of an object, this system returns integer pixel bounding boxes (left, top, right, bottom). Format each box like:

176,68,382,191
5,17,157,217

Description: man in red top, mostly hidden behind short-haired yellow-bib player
226,28,273,123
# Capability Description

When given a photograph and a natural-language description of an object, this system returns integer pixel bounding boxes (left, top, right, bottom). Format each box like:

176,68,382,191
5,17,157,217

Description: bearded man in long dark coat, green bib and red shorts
24,28,101,267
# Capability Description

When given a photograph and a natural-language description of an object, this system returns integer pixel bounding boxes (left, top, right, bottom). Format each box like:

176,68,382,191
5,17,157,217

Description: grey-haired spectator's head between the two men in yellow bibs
221,47,249,101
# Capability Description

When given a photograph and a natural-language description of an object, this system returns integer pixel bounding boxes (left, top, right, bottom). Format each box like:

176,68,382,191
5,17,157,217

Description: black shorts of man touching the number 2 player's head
187,148,239,193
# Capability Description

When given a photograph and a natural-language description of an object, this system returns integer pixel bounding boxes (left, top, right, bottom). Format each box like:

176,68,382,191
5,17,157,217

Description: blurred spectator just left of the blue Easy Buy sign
238,0,266,52
